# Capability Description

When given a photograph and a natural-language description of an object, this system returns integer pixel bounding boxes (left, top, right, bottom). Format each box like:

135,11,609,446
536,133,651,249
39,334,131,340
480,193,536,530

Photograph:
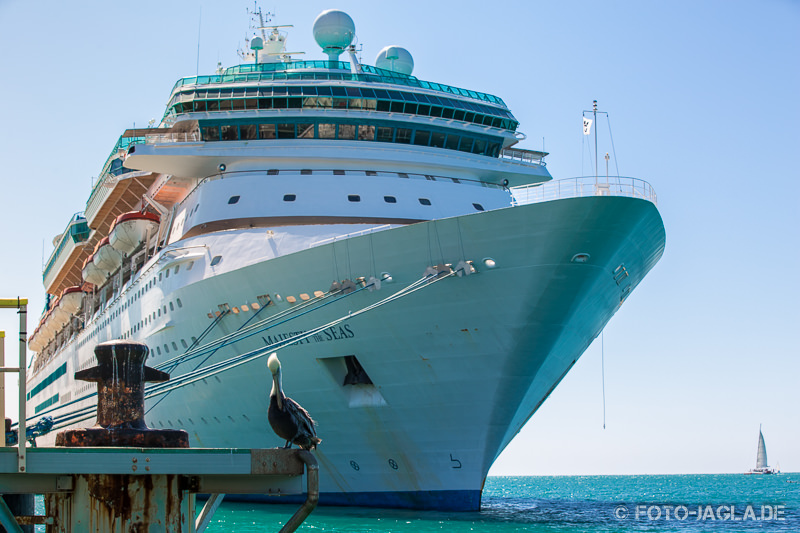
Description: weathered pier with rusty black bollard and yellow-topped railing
0,298,319,533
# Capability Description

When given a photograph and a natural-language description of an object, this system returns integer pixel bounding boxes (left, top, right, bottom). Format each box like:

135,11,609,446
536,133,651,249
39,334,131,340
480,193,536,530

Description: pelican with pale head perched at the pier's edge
267,353,322,450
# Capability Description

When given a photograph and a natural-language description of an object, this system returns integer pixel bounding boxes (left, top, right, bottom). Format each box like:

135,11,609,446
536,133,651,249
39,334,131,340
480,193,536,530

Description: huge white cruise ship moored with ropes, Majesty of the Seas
27,10,666,510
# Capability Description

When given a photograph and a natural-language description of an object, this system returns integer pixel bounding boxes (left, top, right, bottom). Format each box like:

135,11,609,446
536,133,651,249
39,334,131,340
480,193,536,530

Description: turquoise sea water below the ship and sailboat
198,474,800,533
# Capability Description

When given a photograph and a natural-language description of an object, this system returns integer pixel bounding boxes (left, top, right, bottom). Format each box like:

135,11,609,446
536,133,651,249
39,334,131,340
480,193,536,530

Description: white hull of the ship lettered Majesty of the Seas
28,196,665,510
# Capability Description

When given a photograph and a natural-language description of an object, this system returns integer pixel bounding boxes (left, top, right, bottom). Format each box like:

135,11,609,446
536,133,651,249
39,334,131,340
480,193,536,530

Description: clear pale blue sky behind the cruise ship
0,0,800,474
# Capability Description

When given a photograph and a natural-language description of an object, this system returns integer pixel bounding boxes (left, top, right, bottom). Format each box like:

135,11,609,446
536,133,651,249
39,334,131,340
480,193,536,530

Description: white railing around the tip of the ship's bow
511,176,658,205
